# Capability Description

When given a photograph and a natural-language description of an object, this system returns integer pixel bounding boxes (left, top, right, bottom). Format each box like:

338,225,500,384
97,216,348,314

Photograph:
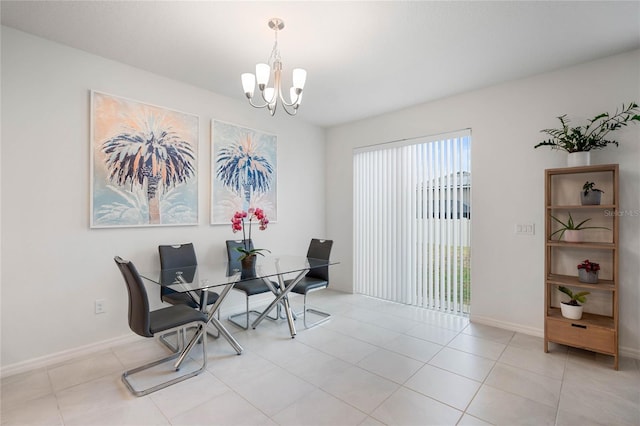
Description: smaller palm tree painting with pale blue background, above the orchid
211,120,277,224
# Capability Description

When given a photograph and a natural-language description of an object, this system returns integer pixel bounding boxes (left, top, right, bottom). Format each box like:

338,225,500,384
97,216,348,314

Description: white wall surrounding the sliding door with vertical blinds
327,51,640,357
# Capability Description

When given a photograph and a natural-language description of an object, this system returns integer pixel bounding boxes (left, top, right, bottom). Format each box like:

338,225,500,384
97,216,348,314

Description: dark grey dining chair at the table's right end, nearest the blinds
285,238,333,328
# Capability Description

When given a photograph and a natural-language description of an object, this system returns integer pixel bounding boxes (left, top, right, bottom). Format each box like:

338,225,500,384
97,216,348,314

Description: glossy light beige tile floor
1,290,640,426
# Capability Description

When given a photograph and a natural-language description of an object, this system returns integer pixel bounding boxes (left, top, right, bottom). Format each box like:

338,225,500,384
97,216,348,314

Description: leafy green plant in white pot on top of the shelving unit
534,102,640,166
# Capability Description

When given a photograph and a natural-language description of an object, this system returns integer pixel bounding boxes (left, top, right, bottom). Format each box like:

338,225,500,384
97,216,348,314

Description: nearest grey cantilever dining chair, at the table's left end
114,256,209,396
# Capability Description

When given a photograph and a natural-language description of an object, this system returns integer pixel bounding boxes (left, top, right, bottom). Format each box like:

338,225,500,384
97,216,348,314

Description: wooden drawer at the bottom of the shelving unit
547,318,616,354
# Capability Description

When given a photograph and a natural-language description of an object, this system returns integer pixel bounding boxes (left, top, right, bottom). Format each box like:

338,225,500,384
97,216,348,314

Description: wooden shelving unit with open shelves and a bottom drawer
544,164,620,370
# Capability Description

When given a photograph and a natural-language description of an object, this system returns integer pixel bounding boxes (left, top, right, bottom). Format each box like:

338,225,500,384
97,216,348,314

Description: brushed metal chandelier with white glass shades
241,18,307,116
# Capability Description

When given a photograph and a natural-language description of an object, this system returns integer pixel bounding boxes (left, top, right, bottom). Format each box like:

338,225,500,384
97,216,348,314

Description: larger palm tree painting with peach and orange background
92,92,198,227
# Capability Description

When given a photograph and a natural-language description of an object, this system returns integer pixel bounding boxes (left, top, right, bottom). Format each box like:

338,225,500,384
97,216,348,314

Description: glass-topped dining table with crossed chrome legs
140,255,339,368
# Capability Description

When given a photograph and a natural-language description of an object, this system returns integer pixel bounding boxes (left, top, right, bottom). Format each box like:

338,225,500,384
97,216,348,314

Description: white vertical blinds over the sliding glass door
353,130,471,313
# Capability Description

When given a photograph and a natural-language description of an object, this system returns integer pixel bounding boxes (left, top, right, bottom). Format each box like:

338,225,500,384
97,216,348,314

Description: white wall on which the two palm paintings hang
1,27,325,372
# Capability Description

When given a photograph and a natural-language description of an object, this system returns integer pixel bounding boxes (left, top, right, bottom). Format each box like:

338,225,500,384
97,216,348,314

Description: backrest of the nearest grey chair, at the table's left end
113,256,153,337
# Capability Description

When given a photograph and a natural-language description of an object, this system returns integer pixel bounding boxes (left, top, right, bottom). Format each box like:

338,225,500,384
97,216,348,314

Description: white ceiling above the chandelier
1,0,640,127
